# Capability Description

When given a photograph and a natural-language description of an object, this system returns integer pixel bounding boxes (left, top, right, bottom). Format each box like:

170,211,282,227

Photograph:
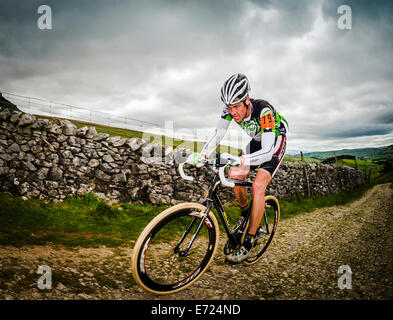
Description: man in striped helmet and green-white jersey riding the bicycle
188,73,288,263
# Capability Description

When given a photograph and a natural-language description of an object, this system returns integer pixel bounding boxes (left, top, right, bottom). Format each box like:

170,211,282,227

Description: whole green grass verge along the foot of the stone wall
0,174,393,247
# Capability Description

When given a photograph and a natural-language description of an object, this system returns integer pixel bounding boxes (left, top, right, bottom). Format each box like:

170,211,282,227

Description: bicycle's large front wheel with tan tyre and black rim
131,203,219,295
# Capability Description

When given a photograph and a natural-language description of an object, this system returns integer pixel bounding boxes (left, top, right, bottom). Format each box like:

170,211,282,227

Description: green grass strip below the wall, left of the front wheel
0,193,166,247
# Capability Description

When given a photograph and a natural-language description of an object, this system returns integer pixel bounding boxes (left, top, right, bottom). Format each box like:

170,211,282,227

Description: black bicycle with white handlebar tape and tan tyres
131,153,280,294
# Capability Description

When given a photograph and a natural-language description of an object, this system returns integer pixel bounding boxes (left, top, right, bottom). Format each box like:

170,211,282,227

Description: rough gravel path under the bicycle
0,184,393,300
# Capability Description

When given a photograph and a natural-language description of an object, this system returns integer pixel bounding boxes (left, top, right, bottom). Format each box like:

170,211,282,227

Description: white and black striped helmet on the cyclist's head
221,73,251,105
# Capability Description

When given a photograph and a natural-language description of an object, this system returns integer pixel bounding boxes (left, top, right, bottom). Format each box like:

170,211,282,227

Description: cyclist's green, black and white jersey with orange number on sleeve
201,99,288,173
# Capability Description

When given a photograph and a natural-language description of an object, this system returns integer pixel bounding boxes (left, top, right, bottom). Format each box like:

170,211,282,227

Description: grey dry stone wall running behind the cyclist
0,107,365,204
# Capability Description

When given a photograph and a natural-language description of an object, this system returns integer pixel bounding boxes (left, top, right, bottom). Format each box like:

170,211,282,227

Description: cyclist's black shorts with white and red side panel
239,135,287,177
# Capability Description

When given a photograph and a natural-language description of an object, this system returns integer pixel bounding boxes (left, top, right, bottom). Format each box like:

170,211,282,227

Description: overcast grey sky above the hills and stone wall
0,0,393,151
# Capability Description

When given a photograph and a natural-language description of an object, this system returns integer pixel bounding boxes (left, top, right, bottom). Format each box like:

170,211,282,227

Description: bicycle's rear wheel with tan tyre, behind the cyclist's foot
243,196,280,265
